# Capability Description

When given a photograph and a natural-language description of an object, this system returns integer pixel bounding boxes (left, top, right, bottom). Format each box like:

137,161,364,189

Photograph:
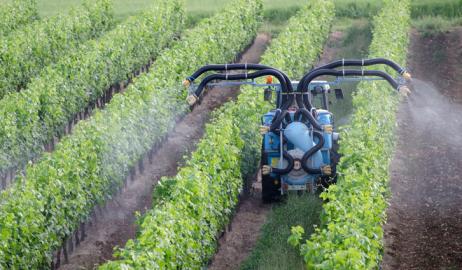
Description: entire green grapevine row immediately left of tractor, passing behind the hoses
100,0,333,270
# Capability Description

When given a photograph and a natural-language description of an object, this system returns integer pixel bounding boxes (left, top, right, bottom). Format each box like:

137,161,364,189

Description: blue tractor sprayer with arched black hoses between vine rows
184,58,411,202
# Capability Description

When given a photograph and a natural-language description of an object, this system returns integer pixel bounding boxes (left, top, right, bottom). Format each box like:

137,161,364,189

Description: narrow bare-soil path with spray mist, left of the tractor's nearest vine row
60,34,269,269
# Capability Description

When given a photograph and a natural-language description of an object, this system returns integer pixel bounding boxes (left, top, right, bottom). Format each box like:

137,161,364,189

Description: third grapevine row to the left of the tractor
0,0,184,190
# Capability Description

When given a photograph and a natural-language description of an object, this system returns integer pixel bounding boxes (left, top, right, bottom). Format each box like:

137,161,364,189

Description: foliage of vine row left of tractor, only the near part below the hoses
100,89,263,269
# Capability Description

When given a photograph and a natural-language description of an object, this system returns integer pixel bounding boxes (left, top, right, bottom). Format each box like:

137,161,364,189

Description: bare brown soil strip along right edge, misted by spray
383,28,462,269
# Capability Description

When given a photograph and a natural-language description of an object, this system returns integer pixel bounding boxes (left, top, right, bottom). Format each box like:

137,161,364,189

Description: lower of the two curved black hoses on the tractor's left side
194,69,289,97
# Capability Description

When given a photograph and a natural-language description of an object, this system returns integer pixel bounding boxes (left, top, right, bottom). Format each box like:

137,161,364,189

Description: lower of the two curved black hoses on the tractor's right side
297,69,399,110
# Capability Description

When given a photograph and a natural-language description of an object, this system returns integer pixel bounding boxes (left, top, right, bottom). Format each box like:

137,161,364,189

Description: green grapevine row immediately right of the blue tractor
294,0,410,269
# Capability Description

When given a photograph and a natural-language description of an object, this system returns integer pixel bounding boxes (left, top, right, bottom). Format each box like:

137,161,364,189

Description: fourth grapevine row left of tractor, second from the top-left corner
0,0,113,99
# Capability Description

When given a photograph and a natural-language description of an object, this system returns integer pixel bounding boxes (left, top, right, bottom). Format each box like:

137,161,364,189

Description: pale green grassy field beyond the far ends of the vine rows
0,0,462,35
